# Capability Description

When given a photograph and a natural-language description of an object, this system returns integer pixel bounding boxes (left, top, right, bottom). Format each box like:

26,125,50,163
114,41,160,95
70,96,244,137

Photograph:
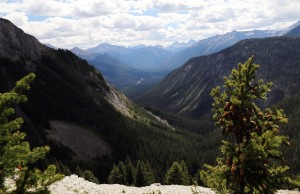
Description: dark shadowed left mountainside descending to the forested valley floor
0,19,216,181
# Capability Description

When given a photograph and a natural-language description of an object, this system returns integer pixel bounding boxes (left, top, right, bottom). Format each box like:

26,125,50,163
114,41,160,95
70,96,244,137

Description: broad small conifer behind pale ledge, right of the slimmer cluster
165,161,190,185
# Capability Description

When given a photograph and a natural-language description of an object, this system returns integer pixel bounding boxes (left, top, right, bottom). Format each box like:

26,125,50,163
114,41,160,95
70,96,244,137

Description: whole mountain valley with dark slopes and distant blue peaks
0,13,300,192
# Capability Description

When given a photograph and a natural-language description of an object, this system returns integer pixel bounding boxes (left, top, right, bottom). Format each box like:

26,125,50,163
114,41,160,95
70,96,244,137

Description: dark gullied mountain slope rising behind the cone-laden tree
142,37,300,118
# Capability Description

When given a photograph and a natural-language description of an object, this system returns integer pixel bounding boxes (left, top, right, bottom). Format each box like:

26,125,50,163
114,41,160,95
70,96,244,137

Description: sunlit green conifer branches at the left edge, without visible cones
0,73,62,193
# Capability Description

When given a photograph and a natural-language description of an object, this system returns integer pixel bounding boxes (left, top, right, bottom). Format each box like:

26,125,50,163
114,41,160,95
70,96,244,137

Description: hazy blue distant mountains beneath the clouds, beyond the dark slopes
71,21,300,99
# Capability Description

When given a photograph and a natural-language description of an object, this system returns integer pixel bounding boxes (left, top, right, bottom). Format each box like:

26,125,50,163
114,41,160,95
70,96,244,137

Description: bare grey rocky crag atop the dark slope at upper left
0,18,43,60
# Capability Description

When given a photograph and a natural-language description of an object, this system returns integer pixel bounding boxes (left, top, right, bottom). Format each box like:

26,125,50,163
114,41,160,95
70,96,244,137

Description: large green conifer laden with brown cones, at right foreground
201,56,290,194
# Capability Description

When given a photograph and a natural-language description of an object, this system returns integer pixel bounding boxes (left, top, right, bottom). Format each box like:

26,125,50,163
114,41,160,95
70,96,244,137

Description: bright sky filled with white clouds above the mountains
0,0,300,49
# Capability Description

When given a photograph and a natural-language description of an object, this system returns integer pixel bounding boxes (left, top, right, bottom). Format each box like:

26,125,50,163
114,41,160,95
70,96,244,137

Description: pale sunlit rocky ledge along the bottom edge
49,175,300,194
